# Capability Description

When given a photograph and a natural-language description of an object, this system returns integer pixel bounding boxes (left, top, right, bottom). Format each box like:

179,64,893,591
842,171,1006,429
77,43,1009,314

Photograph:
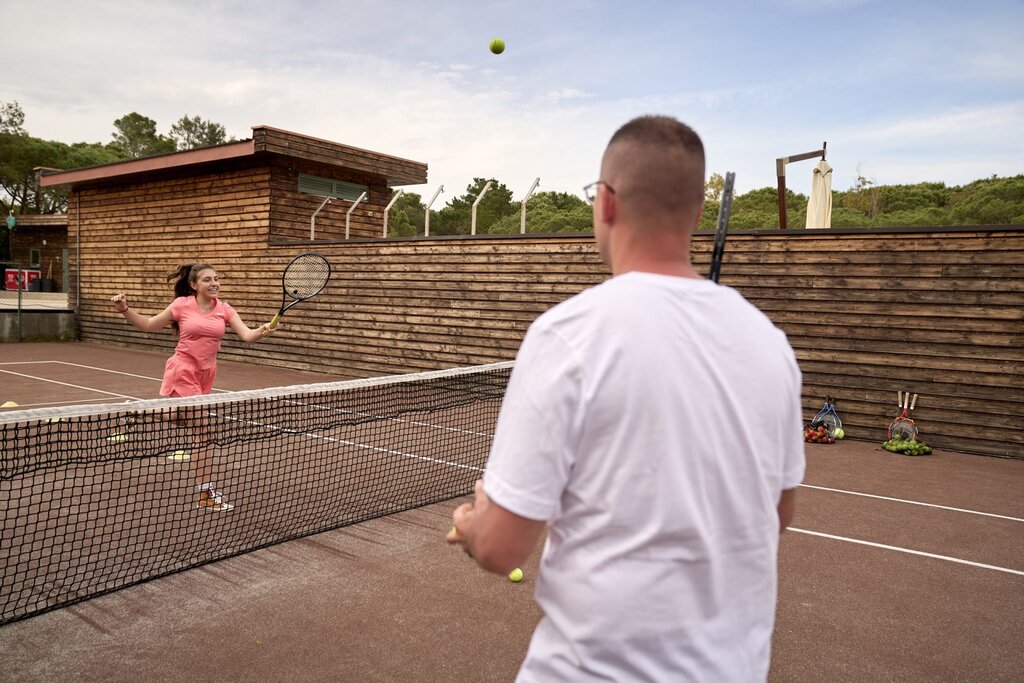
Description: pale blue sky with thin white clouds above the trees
0,0,1024,200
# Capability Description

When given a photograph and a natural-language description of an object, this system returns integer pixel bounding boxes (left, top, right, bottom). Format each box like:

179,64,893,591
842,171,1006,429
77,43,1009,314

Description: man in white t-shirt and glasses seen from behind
447,117,804,683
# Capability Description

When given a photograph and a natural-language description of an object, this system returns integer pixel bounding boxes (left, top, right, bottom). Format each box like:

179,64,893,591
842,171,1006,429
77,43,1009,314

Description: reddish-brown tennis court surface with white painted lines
0,344,1024,681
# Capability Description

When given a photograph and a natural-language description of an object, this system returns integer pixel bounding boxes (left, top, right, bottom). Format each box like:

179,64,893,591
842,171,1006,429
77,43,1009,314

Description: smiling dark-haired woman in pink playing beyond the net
111,263,271,512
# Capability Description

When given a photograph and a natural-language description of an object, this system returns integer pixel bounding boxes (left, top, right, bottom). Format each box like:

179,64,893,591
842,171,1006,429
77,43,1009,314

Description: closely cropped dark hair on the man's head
602,116,705,220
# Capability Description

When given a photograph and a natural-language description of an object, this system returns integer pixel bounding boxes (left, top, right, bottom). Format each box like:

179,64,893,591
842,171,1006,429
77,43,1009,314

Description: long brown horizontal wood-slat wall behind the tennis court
69,176,1024,458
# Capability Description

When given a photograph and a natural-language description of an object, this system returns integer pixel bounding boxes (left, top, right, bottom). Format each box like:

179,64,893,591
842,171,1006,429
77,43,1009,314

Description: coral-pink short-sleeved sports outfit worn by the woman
160,296,234,396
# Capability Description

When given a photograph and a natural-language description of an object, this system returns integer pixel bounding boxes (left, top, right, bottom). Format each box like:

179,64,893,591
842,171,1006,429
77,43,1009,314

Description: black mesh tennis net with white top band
0,362,512,624
